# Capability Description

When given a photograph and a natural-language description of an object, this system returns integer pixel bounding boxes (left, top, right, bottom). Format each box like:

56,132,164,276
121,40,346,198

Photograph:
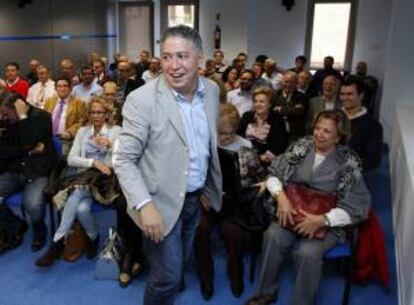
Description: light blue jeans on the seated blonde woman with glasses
53,190,97,242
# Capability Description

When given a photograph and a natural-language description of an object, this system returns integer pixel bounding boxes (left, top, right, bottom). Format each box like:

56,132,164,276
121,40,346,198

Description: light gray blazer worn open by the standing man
114,76,222,235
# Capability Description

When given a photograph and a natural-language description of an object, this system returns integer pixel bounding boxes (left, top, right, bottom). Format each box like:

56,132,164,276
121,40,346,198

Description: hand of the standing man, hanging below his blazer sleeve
139,202,165,243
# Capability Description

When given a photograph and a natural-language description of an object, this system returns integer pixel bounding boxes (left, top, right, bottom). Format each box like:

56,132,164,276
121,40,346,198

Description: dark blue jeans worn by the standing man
144,191,201,305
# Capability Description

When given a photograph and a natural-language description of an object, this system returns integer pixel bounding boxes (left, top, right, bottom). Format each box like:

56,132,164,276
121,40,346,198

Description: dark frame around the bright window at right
305,0,358,71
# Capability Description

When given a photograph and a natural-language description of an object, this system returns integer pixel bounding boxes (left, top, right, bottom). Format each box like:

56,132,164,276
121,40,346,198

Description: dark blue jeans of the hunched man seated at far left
0,172,47,224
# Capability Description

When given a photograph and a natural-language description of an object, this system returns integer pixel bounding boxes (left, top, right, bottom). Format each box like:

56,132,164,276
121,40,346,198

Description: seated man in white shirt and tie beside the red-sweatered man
27,65,56,108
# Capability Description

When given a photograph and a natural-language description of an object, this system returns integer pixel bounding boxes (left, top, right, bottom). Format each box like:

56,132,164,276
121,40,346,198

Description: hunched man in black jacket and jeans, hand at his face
0,92,57,251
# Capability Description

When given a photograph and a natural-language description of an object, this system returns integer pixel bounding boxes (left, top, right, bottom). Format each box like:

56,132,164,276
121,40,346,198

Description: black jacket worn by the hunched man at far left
0,106,57,182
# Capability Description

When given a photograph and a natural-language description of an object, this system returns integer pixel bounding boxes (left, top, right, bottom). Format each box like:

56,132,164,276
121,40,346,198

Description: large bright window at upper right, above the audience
306,0,356,70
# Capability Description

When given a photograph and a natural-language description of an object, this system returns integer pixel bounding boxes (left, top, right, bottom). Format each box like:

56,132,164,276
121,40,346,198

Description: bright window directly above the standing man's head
161,0,198,32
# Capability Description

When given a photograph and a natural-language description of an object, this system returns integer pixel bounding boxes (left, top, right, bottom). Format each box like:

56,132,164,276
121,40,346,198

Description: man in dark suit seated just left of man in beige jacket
272,71,307,143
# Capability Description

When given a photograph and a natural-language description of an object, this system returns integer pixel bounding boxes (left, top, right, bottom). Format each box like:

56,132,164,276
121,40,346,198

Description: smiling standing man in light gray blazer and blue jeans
115,26,221,305
